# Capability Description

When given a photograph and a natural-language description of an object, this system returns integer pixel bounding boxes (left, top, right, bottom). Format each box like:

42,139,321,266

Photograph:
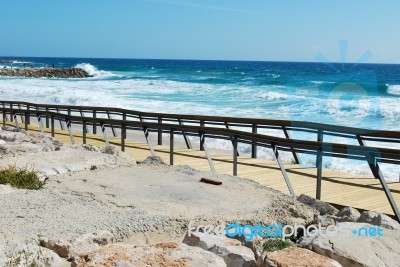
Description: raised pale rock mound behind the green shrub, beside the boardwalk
0,127,136,178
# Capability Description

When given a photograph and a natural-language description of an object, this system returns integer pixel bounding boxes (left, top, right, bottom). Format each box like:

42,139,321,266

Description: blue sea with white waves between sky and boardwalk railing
0,57,400,178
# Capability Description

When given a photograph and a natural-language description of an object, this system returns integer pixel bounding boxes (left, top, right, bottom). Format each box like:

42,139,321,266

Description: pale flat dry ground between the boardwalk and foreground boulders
0,128,315,266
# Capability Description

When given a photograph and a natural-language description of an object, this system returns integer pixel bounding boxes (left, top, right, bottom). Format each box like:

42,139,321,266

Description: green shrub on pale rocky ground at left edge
0,166,43,190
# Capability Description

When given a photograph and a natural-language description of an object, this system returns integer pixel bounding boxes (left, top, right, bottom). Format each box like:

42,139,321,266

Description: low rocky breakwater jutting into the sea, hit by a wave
0,68,93,78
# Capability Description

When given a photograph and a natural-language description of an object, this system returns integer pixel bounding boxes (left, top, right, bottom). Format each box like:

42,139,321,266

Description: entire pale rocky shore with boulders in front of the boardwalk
0,127,400,267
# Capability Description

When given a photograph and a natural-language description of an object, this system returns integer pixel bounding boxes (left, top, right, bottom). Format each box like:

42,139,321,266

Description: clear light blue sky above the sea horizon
0,0,400,63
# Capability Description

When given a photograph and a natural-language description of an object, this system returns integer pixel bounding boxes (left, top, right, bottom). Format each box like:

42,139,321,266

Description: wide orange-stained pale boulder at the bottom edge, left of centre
72,242,226,267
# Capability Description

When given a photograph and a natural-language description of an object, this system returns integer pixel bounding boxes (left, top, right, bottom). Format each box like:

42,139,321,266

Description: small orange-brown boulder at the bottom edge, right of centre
261,247,342,267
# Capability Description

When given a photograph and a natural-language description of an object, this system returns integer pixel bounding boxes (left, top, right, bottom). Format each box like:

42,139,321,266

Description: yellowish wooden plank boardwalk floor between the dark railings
7,123,400,218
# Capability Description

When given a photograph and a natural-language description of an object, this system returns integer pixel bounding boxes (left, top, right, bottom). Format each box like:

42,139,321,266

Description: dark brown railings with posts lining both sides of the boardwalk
0,101,400,221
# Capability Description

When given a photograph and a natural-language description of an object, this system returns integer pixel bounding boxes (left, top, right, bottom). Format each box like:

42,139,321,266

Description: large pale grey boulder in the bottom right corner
298,222,400,267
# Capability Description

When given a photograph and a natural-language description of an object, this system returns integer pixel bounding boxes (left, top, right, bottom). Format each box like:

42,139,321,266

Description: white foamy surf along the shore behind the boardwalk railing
0,75,400,179
